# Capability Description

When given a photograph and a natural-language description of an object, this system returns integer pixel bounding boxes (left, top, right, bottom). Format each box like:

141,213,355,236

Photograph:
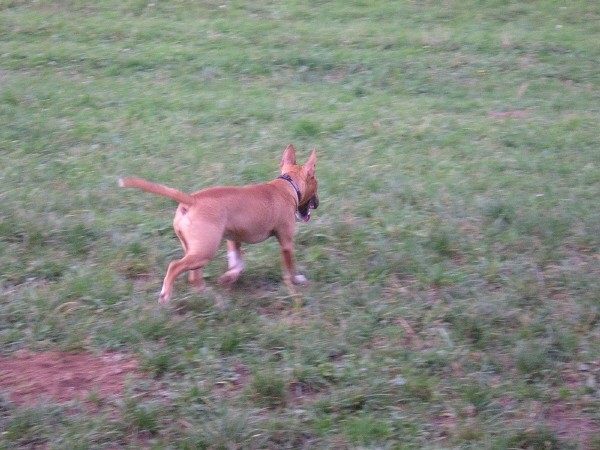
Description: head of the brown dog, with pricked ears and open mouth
279,144,319,222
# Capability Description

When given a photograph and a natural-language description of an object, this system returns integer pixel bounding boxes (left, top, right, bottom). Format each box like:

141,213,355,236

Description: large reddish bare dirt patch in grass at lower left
0,350,139,405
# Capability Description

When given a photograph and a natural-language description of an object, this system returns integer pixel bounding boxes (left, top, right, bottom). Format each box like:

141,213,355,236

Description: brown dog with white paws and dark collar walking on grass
119,144,319,304
